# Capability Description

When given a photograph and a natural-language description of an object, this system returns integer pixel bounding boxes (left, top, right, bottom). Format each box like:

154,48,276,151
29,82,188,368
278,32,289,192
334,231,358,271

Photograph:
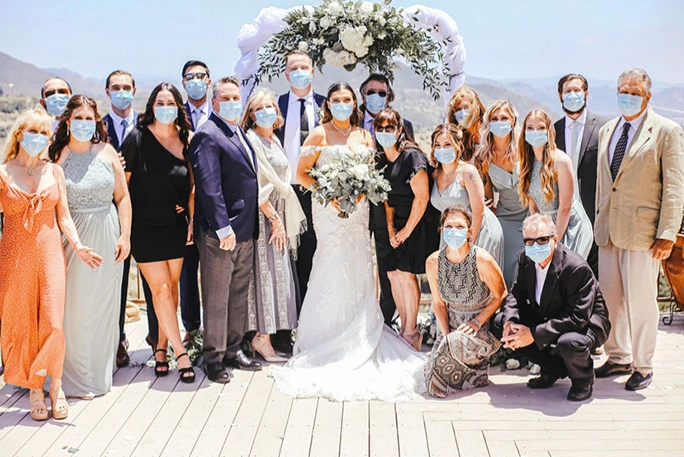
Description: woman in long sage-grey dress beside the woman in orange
49,95,131,399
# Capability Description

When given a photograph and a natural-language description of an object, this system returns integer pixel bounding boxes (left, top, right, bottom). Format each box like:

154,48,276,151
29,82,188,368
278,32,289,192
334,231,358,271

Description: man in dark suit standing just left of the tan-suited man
554,73,606,278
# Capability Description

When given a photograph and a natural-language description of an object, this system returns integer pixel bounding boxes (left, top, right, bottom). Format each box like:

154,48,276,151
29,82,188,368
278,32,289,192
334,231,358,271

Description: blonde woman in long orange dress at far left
0,109,102,420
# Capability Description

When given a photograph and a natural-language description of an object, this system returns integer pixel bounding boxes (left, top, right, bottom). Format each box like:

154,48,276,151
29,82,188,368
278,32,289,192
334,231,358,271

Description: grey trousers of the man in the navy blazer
195,228,254,364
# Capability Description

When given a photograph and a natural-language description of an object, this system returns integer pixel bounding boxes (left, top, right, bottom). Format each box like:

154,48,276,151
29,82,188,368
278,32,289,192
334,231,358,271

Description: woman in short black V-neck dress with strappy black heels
121,83,195,382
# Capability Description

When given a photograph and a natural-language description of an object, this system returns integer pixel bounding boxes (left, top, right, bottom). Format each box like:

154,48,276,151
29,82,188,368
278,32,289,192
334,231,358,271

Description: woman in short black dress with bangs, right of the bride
373,108,430,351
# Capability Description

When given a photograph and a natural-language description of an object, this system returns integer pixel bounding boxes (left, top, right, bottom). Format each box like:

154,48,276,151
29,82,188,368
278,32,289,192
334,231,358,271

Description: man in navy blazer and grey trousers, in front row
189,77,261,383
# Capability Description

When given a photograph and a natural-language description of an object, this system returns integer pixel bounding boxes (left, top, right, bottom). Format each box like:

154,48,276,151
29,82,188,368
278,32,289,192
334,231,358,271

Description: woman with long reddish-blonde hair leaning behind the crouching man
518,110,594,259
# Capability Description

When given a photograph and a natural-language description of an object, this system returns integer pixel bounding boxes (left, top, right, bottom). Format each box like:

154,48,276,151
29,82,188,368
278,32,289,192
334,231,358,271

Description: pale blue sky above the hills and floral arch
0,0,684,83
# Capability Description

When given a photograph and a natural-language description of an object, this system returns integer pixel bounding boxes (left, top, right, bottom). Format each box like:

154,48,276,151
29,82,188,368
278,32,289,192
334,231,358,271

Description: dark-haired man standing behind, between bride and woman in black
360,73,414,325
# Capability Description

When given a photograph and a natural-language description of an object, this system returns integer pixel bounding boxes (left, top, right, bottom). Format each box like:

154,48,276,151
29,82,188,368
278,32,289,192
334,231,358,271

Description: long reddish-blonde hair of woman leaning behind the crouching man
518,109,558,206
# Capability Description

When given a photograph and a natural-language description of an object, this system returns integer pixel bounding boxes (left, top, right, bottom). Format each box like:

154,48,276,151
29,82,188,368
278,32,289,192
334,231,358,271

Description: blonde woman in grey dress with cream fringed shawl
241,89,306,362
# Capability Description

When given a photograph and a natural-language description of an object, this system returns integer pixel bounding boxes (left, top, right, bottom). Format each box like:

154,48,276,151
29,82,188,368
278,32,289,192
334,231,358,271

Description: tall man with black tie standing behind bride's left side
271,51,325,354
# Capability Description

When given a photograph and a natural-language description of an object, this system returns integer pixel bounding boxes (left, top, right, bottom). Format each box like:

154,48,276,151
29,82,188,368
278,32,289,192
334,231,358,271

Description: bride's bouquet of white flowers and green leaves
309,154,391,219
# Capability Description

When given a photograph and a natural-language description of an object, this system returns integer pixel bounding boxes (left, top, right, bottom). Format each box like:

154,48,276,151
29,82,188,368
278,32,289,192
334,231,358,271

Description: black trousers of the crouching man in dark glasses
491,313,596,388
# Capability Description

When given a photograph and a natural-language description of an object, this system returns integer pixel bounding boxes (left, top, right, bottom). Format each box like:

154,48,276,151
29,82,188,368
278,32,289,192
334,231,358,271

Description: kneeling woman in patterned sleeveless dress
425,205,506,398
